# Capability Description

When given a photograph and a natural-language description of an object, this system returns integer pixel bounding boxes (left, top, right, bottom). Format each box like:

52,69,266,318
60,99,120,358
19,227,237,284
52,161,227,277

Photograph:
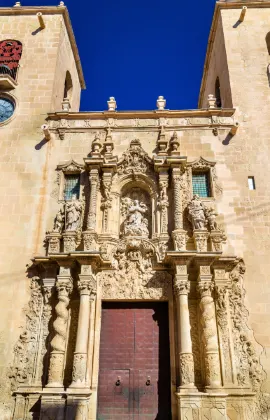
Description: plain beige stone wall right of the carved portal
201,2,270,392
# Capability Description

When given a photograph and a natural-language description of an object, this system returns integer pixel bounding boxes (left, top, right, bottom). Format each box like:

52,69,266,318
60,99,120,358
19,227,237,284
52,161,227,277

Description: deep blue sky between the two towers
0,0,215,111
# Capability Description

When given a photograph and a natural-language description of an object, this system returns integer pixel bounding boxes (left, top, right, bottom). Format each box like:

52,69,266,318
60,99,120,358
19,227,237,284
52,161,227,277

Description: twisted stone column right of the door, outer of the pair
197,264,221,388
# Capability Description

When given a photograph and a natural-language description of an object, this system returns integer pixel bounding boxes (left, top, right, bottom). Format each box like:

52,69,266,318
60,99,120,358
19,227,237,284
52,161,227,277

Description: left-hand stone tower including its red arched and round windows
0,2,85,418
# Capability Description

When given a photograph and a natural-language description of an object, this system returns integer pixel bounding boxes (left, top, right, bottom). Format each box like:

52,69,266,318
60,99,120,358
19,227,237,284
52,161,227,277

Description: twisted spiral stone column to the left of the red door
47,267,72,388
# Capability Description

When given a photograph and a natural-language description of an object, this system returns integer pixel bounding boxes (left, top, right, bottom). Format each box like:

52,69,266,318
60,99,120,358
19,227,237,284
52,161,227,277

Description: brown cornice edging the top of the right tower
198,0,270,108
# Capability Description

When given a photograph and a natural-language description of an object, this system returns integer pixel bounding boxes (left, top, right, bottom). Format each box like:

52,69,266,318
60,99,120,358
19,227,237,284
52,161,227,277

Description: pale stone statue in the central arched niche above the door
124,199,149,237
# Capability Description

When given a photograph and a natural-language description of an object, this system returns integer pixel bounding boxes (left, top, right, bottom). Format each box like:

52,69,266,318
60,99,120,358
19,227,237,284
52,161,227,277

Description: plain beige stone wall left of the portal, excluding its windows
0,9,80,418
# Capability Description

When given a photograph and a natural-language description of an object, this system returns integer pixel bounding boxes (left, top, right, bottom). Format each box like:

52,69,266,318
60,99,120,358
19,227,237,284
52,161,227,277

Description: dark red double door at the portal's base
97,302,171,420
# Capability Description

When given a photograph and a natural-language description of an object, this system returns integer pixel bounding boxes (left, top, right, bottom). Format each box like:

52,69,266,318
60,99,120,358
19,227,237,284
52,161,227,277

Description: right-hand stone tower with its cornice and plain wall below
199,0,270,396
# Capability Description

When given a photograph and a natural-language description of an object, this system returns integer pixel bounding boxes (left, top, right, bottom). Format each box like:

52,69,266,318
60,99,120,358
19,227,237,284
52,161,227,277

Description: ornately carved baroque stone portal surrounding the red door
10,137,264,420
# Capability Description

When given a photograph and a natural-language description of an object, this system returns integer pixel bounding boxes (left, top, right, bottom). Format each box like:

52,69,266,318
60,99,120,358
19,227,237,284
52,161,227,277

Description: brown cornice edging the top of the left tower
0,6,86,89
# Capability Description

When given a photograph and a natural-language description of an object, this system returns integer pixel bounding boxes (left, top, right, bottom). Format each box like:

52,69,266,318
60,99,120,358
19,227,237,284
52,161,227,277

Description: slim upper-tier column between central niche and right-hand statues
172,166,186,251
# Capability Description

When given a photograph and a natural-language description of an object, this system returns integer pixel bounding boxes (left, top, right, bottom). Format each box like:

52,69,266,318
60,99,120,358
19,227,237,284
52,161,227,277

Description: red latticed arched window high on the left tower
0,39,22,80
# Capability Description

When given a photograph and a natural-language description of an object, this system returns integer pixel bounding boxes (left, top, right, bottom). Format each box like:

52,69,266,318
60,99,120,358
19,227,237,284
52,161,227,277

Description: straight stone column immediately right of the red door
174,264,194,390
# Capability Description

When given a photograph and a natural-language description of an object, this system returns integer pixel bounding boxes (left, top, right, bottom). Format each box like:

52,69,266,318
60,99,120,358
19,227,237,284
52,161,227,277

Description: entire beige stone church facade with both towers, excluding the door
0,1,270,420
